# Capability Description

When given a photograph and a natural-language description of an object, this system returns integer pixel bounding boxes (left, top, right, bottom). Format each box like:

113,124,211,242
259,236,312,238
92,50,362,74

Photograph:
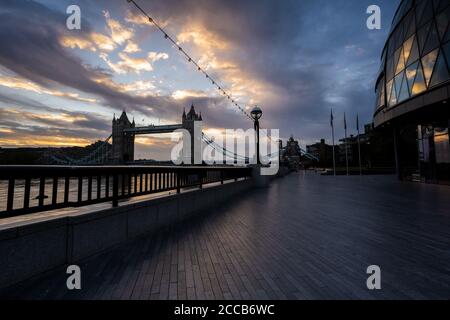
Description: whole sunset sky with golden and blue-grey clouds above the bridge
0,0,399,160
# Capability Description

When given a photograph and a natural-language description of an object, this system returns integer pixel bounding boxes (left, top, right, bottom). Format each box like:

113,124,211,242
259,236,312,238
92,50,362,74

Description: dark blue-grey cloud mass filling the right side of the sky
125,0,399,140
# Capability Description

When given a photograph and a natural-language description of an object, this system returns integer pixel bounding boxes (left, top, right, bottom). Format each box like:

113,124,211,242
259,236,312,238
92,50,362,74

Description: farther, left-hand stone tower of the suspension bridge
112,111,135,164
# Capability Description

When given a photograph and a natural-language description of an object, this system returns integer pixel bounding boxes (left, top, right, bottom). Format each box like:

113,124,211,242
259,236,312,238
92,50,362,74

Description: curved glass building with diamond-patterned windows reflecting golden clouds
374,0,450,183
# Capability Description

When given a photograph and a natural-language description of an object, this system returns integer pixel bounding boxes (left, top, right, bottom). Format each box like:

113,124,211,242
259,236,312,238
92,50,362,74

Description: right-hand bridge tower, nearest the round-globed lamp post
181,104,203,164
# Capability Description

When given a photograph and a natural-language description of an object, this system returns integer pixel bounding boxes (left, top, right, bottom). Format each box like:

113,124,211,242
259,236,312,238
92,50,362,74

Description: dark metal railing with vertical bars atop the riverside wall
0,166,251,218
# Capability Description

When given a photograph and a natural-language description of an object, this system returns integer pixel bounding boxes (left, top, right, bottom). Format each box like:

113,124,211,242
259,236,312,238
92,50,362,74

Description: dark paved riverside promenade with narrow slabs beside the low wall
3,173,450,299
